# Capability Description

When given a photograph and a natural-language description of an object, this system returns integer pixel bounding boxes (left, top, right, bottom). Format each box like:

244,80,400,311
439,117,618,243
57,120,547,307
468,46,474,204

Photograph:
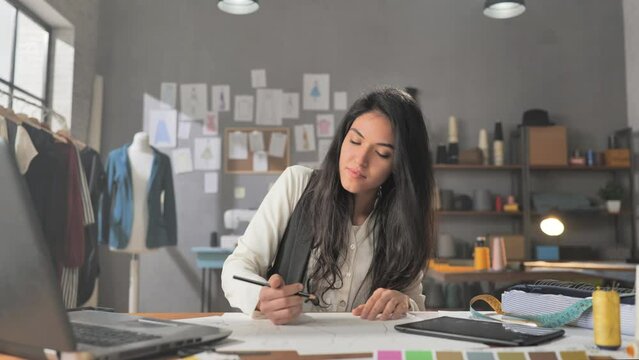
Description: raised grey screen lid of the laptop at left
0,138,75,358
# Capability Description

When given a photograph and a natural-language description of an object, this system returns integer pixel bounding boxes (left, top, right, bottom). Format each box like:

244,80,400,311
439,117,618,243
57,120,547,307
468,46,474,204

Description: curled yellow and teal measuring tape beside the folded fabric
470,294,592,328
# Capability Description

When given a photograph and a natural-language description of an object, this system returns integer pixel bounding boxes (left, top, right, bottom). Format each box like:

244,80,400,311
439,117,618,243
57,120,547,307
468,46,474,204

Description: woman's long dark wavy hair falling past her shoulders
307,88,434,304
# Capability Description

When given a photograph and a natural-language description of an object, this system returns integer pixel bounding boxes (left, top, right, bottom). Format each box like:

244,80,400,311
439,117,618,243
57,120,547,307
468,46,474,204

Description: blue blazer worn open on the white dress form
98,144,177,249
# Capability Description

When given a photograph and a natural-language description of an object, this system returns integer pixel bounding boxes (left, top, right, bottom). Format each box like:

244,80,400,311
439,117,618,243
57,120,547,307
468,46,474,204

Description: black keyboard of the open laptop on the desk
71,323,161,347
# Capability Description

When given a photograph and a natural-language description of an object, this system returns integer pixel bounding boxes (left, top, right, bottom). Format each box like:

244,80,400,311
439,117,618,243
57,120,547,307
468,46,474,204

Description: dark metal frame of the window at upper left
0,0,55,121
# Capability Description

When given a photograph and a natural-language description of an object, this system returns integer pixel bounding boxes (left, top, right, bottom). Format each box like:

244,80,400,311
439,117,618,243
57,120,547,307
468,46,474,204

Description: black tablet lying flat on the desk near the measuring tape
395,316,564,346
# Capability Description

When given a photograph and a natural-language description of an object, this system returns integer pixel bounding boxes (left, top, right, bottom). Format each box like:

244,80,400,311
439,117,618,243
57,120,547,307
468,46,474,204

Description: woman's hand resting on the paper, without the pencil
352,288,410,320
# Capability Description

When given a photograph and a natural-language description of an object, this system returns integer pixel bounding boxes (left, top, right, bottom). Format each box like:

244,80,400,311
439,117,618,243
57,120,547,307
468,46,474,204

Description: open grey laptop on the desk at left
0,138,231,360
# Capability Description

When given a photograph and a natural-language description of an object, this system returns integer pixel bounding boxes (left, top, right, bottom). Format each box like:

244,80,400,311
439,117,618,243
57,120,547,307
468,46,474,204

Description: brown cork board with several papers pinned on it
224,127,289,174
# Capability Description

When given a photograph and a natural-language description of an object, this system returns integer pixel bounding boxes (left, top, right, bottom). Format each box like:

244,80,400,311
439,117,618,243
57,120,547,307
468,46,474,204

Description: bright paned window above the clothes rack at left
0,0,51,119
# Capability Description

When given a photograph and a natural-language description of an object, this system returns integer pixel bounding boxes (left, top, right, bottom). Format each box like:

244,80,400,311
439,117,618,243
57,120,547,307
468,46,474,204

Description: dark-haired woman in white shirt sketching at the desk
222,88,434,324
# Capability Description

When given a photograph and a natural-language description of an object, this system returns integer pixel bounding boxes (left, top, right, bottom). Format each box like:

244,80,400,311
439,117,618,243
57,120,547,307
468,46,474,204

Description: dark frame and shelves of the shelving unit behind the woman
434,127,639,262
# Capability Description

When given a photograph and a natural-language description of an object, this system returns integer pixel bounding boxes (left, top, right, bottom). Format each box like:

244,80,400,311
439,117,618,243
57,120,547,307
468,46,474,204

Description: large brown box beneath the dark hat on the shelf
528,125,568,165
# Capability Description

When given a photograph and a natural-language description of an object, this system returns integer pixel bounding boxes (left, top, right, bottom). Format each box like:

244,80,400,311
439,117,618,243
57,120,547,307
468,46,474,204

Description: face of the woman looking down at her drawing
339,111,395,194
